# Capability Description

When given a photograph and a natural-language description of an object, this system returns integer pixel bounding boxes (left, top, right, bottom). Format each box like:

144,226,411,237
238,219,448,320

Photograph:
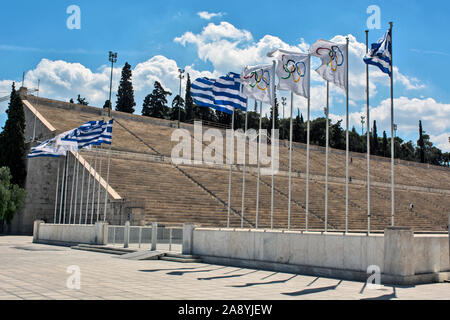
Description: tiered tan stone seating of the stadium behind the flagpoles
29,97,450,230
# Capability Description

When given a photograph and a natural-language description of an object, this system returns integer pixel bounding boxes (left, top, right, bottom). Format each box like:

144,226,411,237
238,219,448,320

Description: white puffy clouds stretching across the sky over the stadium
0,20,450,151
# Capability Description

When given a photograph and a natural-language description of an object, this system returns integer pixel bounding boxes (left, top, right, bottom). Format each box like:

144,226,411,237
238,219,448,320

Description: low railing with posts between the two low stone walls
108,223,183,252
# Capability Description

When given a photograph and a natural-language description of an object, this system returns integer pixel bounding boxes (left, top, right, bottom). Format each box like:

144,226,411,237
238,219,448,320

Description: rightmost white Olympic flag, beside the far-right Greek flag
309,39,348,90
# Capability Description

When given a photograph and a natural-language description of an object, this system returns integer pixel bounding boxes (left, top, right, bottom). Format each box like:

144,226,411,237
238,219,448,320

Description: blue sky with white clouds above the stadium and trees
0,0,450,150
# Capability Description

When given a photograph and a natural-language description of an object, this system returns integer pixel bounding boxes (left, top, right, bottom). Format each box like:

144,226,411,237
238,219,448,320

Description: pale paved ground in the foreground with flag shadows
0,236,450,300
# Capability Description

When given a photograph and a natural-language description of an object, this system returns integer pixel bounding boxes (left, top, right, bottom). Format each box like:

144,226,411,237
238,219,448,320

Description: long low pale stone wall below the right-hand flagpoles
183,225,450,285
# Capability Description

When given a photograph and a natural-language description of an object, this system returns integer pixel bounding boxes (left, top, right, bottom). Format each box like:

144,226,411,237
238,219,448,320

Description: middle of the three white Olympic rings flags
267,49,310,98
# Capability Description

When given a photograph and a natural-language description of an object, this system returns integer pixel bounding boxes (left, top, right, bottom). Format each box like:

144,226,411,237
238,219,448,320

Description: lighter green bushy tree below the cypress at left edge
0,167,25,229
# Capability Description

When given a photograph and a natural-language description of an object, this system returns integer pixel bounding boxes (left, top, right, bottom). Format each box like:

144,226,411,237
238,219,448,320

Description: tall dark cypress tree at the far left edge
0,83,27,188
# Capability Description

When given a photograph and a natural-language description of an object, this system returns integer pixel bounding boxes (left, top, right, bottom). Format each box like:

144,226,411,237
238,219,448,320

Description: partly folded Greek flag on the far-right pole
364,30,392,76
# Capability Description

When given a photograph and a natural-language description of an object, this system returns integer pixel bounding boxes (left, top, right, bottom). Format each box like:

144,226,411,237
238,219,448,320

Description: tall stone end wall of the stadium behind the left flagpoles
8,96,131,234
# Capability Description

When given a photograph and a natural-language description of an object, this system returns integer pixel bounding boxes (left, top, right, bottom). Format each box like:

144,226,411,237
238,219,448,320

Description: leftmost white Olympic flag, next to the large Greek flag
241,64,275,104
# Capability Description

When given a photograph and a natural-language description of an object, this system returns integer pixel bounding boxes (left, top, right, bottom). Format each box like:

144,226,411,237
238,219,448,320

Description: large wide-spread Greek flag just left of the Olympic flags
191,72,247,114
